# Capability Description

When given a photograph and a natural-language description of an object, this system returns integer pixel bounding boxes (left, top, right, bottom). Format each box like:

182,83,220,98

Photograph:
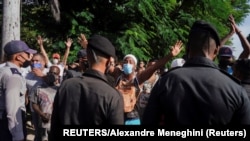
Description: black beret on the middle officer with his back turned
88,35,116,57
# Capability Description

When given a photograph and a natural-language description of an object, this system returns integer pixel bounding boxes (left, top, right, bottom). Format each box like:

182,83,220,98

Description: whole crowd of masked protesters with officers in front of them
0,16,250,141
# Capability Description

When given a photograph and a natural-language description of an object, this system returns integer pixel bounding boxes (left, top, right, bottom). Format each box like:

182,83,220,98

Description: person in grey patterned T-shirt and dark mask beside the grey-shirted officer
30,66,60,141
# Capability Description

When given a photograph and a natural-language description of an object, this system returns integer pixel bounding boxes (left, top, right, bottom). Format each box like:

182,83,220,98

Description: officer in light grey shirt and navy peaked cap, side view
0,40,36,141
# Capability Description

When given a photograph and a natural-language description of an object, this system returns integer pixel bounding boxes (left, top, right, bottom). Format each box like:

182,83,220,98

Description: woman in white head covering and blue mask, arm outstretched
116,41,182,125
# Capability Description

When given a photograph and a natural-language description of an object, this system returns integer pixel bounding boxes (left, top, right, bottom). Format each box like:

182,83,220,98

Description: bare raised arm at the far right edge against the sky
229,15,250,59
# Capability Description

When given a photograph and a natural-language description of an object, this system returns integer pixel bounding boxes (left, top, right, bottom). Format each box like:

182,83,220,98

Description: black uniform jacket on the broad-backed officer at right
142,57,250,125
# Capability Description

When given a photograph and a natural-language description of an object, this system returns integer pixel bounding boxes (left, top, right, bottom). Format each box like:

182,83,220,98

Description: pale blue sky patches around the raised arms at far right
232,14,250,59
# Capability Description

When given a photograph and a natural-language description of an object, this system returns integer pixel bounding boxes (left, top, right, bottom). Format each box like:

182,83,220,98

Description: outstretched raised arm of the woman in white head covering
137,41,183,85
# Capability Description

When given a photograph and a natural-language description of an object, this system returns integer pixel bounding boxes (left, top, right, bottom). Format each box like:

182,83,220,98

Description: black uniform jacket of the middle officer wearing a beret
51,70,124,128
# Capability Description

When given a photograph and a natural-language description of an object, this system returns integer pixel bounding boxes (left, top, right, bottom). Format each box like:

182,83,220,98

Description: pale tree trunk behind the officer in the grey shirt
1,0,20,61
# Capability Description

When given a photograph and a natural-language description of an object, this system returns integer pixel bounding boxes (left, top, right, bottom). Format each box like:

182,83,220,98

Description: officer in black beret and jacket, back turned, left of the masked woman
49,35,124,140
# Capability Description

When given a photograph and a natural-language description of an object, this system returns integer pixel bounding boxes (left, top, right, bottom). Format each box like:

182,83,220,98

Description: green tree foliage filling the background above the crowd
2,0,250,65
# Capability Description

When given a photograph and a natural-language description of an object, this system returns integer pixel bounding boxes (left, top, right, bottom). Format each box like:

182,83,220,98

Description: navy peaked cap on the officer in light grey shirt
4,40,37,55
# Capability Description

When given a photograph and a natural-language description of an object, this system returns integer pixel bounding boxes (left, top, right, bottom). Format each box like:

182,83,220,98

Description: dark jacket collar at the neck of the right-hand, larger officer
183,56,219,69
